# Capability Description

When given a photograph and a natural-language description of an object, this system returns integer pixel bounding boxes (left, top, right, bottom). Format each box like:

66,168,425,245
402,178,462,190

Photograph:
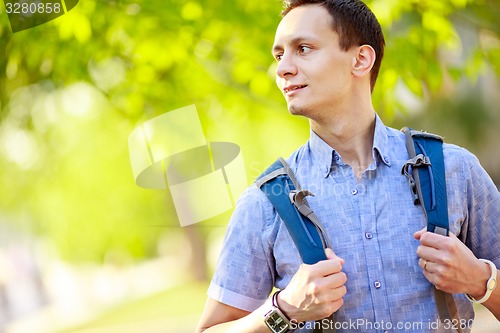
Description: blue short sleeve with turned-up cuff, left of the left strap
208,185,275,312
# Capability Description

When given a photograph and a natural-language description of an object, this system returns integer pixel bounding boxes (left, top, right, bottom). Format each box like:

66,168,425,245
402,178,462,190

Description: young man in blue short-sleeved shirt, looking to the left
197,0,500,333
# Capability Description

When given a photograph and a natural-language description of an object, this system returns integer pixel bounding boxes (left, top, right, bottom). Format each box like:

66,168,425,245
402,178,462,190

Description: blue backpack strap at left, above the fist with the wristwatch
255,157,330,264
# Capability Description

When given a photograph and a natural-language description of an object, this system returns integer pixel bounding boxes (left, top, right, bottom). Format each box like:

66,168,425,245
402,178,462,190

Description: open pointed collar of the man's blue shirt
309,114,391,178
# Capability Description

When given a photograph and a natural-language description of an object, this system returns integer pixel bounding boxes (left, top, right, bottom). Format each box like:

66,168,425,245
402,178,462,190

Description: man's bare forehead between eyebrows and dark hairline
275,5,337,46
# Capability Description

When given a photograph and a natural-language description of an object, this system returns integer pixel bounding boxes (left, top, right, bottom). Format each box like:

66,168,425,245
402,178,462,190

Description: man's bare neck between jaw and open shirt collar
310,104,375,181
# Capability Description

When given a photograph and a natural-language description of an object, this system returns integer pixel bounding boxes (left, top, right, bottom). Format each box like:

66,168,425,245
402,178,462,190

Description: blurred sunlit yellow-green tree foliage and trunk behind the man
0,0,500,272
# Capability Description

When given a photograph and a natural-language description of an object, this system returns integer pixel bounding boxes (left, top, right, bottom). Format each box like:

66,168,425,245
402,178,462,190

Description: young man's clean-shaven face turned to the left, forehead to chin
273,5,356,119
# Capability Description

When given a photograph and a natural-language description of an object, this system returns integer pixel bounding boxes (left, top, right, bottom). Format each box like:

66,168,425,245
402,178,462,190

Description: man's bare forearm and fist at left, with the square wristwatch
196,249,347,333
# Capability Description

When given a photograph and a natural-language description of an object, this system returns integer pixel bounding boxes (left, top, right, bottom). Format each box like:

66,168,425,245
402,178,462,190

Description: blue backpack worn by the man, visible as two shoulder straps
255,127,462,333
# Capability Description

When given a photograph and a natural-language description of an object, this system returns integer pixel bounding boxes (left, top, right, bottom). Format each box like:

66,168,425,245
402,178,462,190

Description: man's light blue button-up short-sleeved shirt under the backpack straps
208,116,500,333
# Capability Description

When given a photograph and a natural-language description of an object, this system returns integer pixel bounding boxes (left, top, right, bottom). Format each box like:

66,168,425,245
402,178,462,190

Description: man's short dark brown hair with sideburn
281,0,385,91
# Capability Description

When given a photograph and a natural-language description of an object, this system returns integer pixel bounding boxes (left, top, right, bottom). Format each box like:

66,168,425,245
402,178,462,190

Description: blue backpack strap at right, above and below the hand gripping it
401,127,462,333
